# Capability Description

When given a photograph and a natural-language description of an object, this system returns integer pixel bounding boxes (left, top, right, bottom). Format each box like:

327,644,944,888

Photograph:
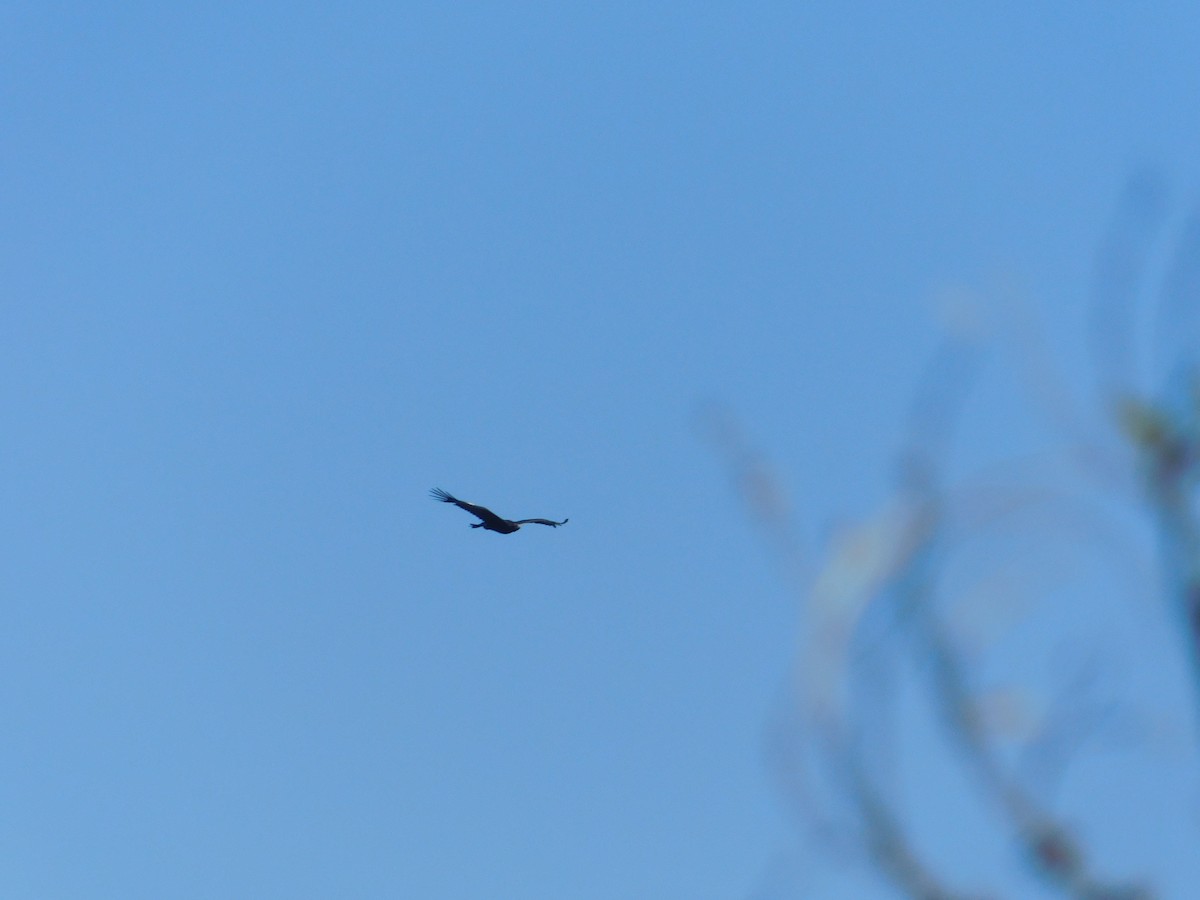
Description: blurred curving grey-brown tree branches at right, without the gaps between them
703,175,1200,900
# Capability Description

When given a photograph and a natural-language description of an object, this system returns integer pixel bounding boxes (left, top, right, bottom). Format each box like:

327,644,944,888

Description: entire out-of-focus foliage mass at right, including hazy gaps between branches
709,174,1200,899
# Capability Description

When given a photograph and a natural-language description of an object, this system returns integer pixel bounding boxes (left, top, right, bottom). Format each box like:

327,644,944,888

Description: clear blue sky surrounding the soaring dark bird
7,0,1200,900
